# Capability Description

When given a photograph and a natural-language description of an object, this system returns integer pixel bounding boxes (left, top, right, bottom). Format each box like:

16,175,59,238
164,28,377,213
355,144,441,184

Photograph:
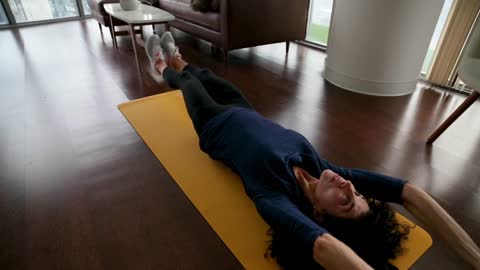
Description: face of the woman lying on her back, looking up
312,170,369,219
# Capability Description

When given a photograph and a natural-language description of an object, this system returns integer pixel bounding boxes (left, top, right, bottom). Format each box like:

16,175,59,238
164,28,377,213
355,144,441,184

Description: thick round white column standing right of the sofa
324,0,444,96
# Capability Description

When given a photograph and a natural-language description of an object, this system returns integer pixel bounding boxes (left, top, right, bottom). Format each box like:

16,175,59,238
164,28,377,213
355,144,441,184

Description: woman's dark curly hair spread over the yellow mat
265,199,410,270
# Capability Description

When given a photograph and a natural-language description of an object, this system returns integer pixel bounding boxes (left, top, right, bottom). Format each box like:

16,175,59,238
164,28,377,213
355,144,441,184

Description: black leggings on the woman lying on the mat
163,65,253,135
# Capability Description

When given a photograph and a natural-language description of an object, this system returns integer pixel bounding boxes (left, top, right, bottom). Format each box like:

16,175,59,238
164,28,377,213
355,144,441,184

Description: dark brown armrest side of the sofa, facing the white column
220,0,309,50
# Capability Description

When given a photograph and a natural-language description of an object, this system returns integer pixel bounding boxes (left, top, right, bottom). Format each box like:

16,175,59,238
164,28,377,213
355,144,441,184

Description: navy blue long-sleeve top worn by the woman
199,107,405,250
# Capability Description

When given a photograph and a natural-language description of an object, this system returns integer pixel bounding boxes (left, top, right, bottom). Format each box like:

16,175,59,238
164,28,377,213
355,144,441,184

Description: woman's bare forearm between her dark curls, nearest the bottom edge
313,233,373,270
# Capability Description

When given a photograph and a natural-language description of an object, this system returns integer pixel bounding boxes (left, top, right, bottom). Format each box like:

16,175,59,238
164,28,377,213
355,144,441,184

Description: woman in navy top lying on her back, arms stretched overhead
146,32,480,270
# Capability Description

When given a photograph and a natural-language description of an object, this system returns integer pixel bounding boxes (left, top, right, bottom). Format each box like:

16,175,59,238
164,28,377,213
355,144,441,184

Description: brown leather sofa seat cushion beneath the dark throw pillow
159,0,220,32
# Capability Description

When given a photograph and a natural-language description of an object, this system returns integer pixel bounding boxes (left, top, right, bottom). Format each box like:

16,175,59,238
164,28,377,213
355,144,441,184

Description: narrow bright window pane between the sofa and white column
307,0,333,45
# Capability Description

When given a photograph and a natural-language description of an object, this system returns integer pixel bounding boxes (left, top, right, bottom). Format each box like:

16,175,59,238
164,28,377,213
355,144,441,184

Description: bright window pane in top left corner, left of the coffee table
8,0,79,23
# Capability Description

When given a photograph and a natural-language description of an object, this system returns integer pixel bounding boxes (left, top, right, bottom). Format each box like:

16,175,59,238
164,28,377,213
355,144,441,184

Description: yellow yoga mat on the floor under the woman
118,91,432,270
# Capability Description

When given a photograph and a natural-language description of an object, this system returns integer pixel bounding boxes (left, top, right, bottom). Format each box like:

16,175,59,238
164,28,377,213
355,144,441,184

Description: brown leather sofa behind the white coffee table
154,0,309,61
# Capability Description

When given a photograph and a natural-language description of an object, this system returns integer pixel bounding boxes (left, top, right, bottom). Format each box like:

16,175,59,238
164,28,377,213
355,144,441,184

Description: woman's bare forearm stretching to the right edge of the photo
402,183,480,270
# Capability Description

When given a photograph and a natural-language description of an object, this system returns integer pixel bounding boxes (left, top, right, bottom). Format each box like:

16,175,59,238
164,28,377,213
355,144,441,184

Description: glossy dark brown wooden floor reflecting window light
0,17,480,270
